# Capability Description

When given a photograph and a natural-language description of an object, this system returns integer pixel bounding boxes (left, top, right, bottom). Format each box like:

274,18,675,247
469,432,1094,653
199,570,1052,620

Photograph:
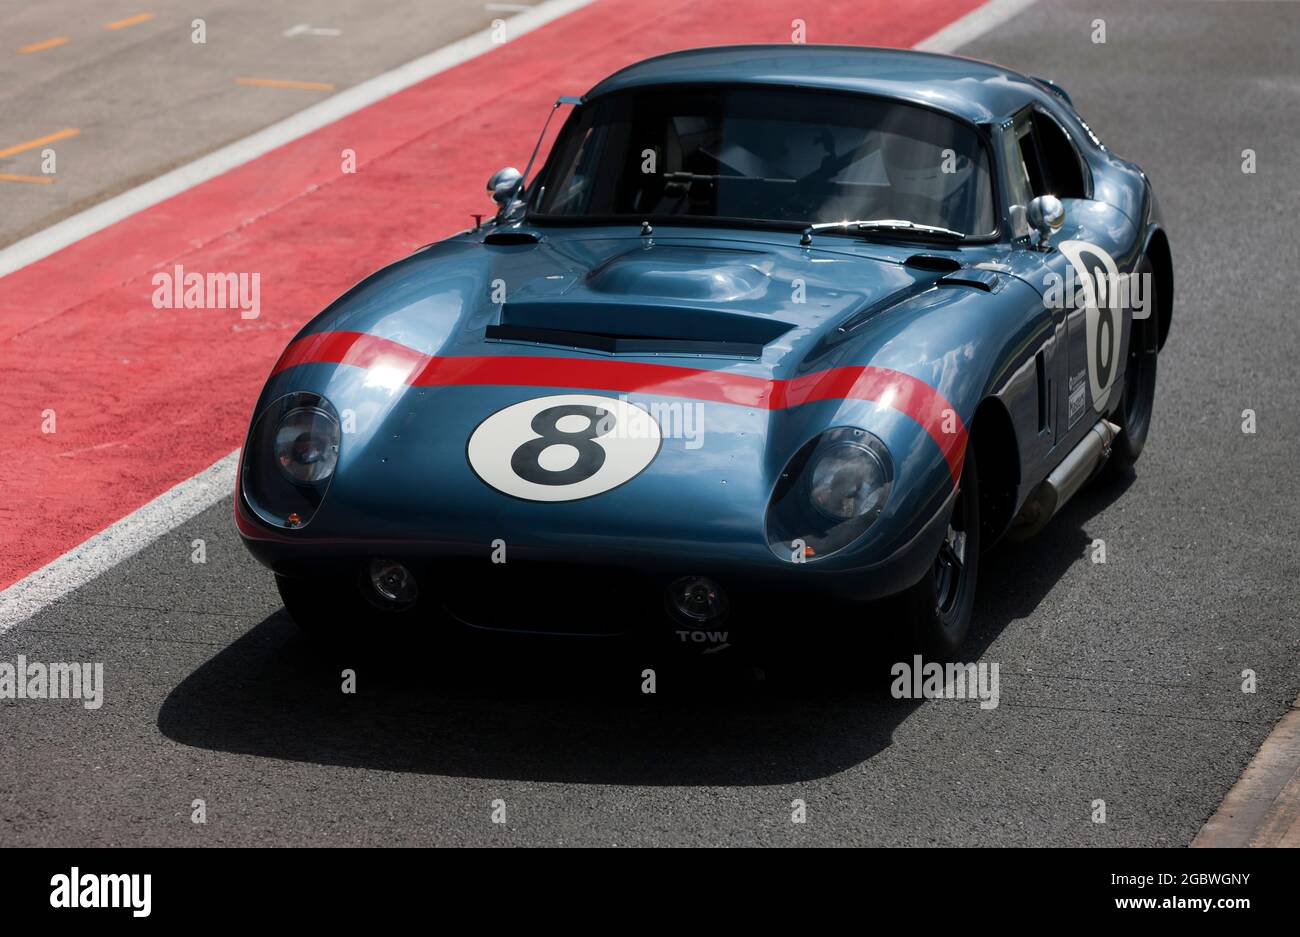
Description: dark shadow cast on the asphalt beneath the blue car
159,470,1127,785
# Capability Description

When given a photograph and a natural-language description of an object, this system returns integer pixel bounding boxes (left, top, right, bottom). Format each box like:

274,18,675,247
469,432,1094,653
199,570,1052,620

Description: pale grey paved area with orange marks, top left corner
0,0,532,247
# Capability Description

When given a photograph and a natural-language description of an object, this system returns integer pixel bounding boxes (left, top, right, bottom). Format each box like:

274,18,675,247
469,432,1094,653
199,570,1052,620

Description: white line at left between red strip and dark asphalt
0,450,239,634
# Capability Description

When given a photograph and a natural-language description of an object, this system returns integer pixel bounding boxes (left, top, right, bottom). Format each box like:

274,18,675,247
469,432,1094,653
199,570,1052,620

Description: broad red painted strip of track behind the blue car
0,0,980,586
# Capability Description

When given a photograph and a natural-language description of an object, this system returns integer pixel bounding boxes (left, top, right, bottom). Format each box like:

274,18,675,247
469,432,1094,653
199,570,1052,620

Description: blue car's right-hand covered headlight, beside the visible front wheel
767,426,893,563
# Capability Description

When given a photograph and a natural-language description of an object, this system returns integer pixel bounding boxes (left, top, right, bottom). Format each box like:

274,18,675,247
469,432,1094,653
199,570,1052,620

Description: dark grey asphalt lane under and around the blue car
0,0,1300,846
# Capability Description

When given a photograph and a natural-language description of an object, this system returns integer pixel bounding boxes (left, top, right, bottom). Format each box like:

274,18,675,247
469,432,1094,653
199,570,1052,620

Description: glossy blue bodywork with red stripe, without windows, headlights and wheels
235,45,1173,639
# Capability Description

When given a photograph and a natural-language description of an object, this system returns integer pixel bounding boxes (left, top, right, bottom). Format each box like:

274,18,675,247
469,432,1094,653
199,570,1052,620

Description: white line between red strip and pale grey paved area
0,0,593,277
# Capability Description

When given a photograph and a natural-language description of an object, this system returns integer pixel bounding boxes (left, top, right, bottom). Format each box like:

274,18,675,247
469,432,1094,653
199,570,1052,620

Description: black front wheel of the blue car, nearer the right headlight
900,446,980,660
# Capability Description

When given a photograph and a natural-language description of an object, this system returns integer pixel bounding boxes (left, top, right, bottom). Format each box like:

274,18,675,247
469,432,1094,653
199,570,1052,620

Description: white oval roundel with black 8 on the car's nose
467,394,662,502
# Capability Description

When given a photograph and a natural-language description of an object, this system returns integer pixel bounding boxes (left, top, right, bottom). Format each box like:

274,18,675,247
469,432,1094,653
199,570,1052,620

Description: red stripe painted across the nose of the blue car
273,331,966,485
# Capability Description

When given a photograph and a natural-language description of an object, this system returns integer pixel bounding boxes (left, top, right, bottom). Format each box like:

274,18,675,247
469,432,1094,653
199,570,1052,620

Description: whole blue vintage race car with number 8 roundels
235,45,1173,658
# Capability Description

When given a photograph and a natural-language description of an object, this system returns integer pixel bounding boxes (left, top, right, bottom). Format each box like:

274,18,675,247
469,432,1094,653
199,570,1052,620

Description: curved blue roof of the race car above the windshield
585,43,1045,123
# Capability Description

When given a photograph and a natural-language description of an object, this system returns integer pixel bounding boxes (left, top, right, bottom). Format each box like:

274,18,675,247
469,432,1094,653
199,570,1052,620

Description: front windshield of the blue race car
529,87,996,237
